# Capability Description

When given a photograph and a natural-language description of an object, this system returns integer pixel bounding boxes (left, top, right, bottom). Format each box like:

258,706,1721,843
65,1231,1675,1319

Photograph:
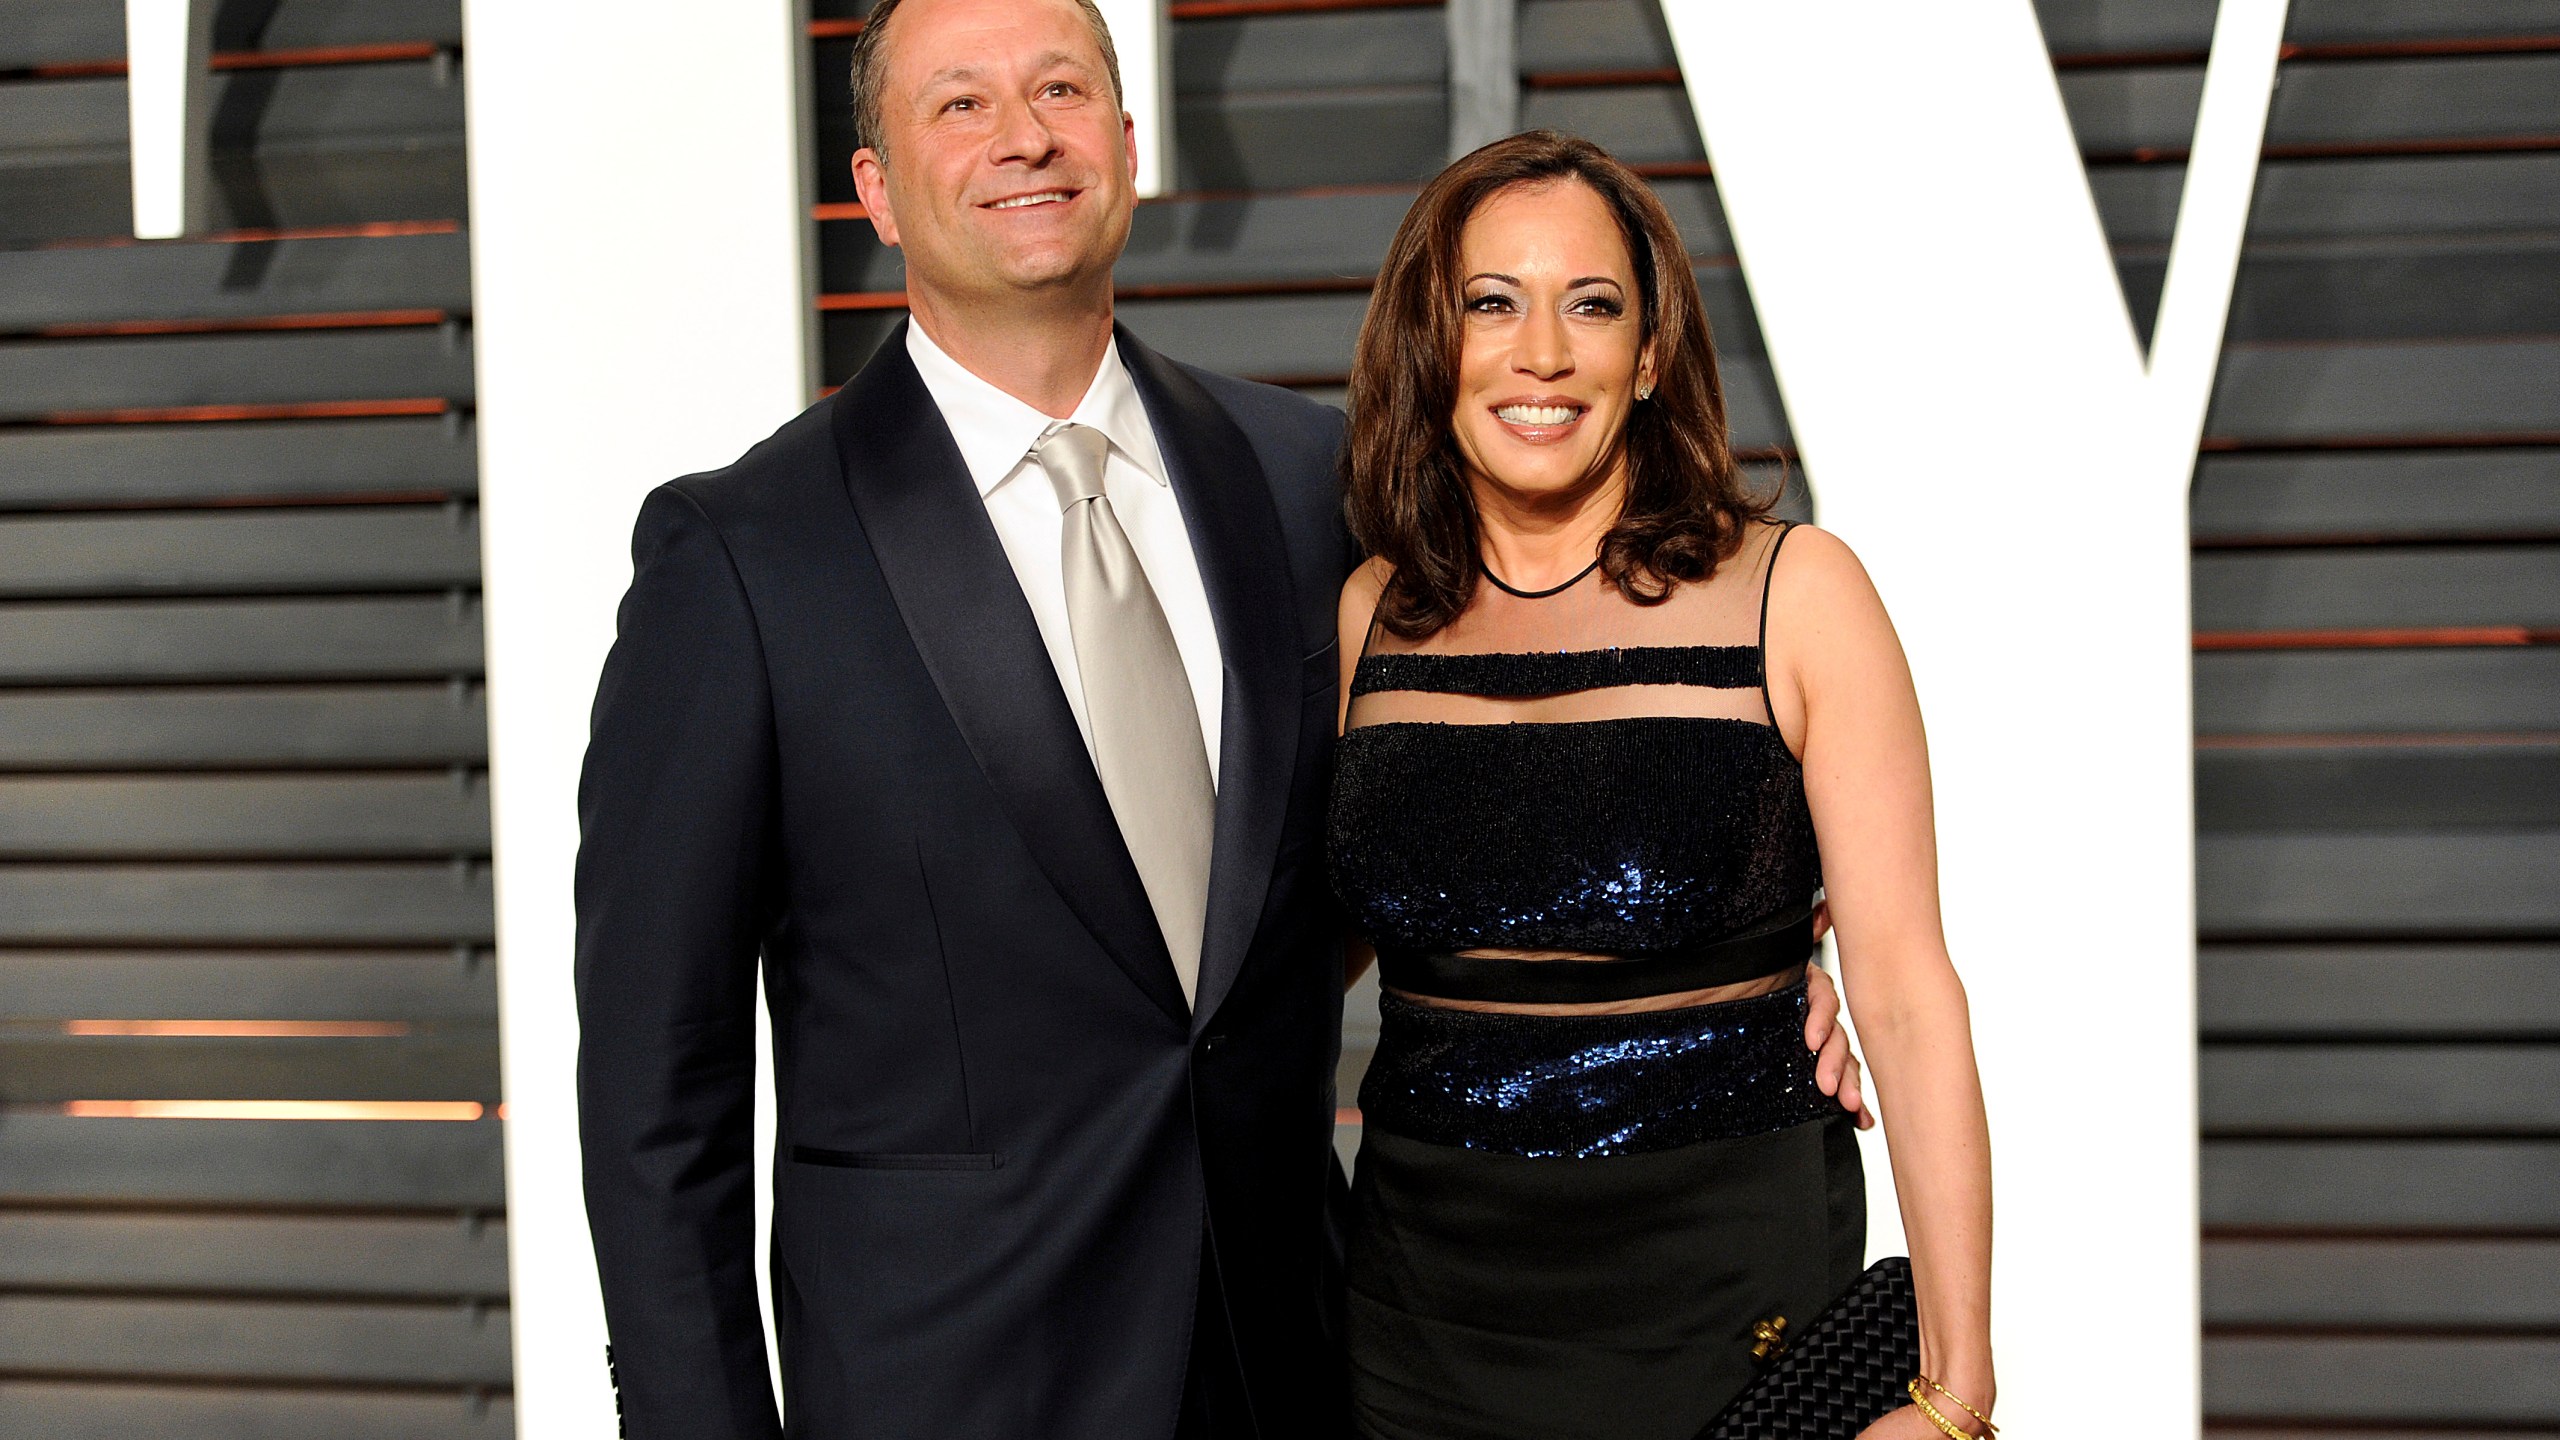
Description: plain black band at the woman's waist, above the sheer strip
1377,907,1812,1004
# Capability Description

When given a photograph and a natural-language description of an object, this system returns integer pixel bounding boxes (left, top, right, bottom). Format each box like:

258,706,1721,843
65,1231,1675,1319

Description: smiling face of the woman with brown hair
1452,179,1654,500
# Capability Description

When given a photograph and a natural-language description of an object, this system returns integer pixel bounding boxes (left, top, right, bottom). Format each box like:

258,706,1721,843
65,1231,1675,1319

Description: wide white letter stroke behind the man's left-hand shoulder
463,0,812,1440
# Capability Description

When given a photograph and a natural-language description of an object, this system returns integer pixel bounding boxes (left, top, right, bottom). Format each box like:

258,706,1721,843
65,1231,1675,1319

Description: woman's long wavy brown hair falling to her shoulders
1341,131,1774,641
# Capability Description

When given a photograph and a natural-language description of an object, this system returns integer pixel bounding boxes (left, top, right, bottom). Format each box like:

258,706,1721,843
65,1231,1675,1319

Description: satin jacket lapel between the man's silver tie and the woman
1119,328,1298,1030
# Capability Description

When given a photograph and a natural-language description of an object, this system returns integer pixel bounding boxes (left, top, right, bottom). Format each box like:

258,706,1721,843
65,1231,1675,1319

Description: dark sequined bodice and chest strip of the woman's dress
1329,646,1823,973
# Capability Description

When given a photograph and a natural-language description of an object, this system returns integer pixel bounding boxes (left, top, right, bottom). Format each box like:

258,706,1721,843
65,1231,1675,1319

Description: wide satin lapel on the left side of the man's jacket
835,325,1185,1020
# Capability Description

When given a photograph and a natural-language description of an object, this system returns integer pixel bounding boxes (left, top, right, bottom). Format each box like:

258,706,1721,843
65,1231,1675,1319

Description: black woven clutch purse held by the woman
1697,1256,1920,1440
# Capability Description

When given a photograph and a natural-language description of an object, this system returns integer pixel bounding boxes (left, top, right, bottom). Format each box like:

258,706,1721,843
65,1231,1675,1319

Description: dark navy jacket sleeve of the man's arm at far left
576,487,781,1440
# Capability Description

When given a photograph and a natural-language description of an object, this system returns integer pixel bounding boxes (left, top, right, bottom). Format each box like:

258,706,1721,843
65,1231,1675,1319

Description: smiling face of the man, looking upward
852,0,1137,302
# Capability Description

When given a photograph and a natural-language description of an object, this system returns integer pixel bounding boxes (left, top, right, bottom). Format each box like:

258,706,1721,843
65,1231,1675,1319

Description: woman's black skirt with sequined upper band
1349,986,1866,1440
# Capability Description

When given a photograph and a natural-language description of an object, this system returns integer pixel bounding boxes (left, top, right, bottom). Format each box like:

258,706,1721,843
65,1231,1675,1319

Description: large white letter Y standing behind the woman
1664,0,2286,1437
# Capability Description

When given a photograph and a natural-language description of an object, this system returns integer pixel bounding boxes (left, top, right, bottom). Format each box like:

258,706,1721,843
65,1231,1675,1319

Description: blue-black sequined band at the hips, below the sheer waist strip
1359,978,1836,1158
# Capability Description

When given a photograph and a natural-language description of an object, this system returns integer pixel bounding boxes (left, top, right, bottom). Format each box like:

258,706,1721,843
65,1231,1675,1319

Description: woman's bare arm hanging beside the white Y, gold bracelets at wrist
1769,528,1994,1437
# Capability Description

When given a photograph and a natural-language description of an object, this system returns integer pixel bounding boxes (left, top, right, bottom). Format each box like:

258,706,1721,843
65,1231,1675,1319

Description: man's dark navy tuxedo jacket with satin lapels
576,331,1354,1440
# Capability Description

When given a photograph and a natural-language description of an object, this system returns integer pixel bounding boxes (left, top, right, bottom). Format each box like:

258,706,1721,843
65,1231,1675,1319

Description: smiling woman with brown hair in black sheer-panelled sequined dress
1329,133,1992,1440
